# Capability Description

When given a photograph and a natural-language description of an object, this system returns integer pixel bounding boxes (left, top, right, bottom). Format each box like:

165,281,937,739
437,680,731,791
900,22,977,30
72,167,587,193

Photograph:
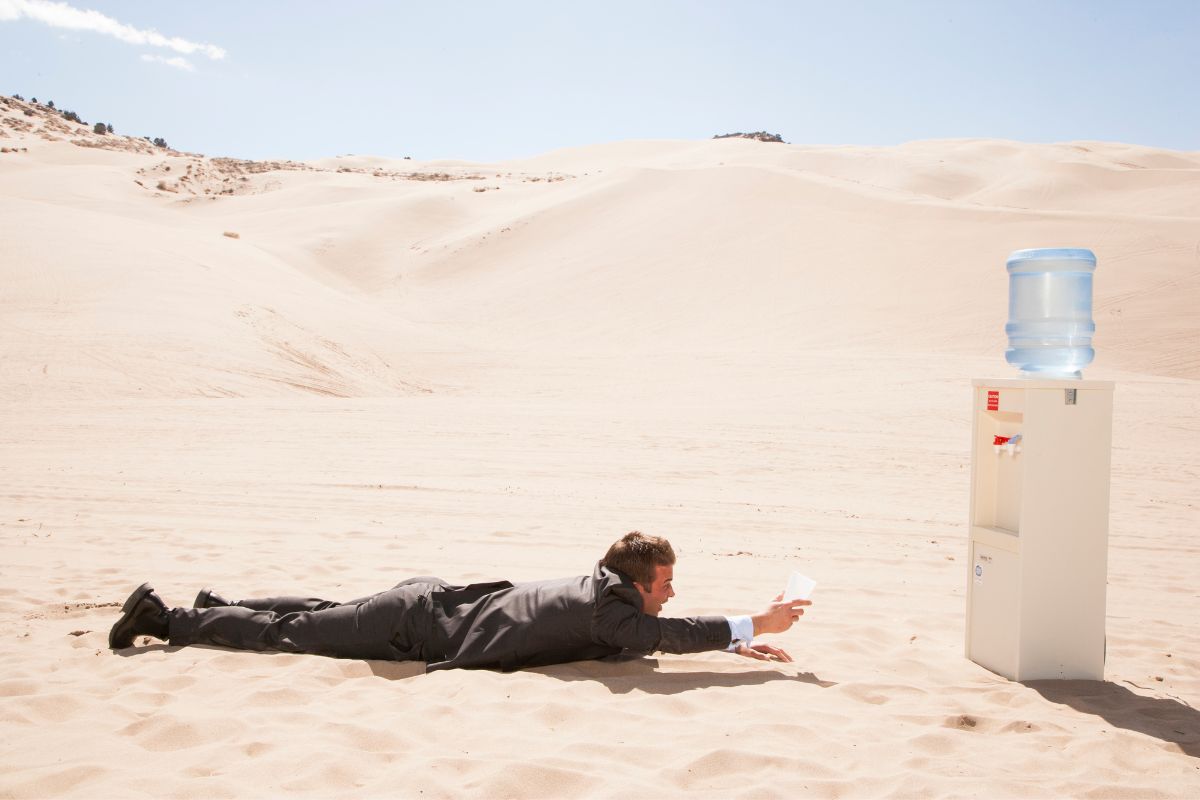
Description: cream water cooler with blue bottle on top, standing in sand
966,251,1114,681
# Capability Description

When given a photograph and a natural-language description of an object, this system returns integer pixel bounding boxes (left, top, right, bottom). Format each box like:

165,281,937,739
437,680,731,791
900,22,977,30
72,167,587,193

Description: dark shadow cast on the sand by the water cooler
1022,680,1200,758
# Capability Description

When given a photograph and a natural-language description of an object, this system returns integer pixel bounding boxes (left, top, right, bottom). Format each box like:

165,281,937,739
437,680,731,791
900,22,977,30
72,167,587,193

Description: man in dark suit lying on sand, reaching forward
108,531,811,670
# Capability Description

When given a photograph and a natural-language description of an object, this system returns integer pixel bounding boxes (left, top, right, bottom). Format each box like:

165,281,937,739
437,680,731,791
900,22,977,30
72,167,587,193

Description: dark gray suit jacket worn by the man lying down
424,564,732,672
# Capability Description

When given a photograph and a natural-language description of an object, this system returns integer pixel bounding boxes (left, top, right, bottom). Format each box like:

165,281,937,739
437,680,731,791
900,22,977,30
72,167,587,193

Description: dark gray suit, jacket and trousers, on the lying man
168,565,731,670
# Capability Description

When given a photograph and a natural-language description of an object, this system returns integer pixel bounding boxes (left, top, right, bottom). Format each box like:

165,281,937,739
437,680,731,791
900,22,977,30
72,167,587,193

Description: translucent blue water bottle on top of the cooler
1004,248,1096,378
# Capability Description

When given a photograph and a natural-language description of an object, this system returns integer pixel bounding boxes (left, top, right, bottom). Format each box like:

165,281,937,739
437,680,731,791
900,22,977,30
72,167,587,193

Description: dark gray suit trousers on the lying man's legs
168,577,448,661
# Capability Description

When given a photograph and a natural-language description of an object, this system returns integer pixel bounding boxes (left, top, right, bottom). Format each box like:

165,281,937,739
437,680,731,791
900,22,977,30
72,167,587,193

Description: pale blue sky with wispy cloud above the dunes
0,0,1200,161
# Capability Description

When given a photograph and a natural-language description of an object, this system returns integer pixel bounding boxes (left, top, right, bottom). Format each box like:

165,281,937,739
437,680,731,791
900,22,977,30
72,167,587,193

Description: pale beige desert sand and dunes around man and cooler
0,98,1200,798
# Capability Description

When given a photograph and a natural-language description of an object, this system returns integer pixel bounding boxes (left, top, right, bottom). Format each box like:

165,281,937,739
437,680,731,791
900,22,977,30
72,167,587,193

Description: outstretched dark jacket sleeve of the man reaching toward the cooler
592,581,732,652
